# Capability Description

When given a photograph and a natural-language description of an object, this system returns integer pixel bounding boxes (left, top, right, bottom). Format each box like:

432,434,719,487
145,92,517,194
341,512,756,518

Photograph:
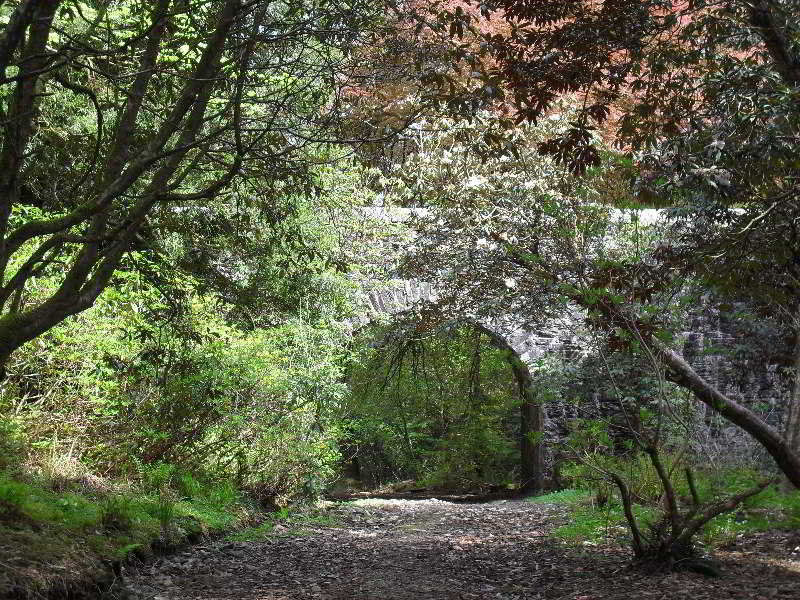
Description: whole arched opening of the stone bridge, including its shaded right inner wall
345,315,545,493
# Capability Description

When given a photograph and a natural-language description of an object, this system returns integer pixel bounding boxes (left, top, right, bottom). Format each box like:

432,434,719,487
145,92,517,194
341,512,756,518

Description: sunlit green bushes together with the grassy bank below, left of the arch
0,188,356,596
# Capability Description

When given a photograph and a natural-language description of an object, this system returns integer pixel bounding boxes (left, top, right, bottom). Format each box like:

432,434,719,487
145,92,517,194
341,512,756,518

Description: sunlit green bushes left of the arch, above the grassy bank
0,260,345,497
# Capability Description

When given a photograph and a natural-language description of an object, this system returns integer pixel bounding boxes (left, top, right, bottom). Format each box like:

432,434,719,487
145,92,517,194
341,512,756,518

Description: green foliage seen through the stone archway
345,327,518,488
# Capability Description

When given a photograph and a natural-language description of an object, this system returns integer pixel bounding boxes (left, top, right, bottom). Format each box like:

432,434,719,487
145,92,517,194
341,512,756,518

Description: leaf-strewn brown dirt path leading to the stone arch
124,499,800,600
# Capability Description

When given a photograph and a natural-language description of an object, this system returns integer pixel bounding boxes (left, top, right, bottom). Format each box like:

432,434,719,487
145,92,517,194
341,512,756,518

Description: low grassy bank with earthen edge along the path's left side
0,473,254,597
